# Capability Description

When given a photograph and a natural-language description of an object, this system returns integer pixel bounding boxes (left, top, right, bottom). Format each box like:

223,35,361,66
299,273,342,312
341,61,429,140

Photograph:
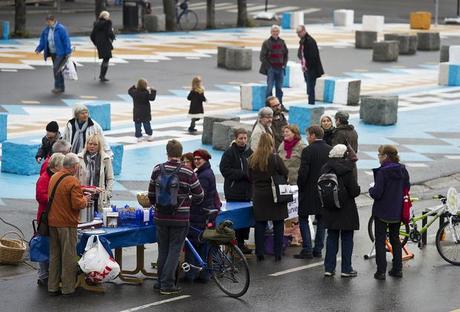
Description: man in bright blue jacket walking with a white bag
35,15,72,94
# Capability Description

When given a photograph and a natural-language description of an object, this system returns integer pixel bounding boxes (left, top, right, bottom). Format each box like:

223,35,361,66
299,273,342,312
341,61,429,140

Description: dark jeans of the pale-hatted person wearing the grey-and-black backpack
324,229,353,273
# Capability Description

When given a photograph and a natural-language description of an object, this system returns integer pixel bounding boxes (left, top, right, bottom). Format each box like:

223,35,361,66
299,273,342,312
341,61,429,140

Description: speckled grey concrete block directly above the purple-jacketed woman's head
360,95,398,126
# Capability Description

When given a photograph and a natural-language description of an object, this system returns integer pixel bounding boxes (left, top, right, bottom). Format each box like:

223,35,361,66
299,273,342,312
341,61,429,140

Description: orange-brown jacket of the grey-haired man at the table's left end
48,169,86,227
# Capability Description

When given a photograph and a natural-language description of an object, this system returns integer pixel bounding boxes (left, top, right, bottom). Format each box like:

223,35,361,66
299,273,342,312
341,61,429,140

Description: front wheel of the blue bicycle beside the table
208,244,250,298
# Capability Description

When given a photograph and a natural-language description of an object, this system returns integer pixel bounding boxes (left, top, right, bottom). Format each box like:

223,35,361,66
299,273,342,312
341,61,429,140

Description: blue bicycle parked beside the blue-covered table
180,209,250,298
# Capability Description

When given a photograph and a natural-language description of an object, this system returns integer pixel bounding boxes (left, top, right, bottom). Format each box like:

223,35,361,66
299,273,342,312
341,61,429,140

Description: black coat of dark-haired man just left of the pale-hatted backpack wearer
297,140,332,217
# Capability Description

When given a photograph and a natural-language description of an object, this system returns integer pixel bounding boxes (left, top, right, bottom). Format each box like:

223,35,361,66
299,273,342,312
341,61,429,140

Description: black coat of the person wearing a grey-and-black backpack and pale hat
321,158,361,230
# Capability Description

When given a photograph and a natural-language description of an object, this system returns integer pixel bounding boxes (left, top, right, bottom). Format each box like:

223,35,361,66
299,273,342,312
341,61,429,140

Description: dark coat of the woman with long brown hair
249,155,289,221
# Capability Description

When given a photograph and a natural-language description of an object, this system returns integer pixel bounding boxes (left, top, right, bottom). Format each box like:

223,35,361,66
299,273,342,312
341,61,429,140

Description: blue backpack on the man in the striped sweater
155,164,184,215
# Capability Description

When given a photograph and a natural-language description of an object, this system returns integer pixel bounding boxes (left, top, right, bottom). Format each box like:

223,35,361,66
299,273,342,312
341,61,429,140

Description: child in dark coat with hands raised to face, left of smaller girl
128,79,157,142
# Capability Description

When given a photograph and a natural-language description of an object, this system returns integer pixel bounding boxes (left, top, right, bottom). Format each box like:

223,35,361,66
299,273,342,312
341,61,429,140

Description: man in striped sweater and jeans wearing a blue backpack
148,140,204,295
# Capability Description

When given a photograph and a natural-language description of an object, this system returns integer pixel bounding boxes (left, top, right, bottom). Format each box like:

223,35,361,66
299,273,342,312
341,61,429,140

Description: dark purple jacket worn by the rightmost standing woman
369,162,410,221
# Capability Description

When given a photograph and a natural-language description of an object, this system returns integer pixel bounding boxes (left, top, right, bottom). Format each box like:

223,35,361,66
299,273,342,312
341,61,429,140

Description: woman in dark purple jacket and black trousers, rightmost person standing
369,145,410,280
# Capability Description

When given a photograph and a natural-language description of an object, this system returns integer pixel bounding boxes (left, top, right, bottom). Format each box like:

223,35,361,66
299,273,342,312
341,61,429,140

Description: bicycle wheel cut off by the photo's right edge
436,220,460,265
